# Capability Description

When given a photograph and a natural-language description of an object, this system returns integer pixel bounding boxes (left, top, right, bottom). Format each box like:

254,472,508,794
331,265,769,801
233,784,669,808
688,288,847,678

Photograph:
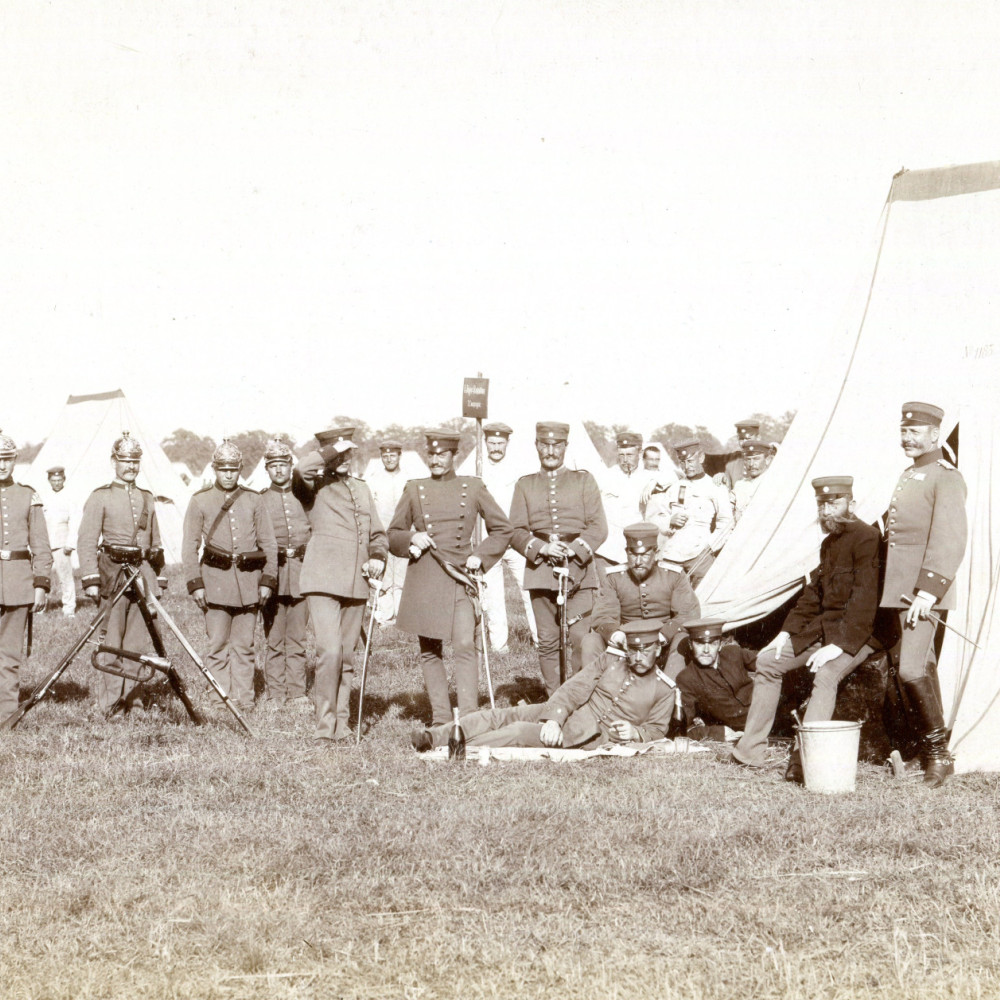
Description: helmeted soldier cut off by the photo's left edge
0,433,52,722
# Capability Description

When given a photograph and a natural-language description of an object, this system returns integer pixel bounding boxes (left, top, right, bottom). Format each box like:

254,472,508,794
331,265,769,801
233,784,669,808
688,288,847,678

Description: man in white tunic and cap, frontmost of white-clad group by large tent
646,438,733,587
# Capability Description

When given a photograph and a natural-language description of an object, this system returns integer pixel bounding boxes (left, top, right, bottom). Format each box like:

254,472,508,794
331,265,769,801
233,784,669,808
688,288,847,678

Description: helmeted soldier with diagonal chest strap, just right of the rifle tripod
182,440,278,711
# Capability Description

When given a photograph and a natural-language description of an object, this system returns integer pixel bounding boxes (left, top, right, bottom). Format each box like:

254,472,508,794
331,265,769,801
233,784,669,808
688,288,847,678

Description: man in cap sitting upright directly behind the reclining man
583,522,701,663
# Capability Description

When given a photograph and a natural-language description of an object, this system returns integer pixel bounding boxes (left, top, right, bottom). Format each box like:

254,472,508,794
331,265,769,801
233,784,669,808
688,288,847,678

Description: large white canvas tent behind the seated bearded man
698,162,1000,771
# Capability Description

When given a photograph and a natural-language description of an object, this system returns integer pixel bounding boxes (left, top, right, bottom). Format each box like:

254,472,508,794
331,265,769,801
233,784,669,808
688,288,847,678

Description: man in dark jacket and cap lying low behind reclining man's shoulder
665,618,757,740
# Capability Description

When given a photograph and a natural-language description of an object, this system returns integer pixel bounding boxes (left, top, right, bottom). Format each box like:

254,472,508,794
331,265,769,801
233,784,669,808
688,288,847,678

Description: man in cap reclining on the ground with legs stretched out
411,619,674,751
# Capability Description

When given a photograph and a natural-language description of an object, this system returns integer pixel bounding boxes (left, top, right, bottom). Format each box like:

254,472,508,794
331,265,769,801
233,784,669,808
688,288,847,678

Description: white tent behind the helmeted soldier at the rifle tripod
26,389,190,563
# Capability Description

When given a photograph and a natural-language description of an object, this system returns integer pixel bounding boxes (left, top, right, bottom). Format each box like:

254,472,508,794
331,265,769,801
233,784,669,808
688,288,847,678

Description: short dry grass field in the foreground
0,580,1000,1000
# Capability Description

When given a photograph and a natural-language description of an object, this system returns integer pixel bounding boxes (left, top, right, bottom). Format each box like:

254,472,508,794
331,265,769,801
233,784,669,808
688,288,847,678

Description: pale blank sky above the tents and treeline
0,0,1000,441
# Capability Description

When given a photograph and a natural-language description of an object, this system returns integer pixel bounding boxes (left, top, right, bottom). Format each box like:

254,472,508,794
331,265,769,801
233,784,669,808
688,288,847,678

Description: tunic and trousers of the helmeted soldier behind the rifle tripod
77,479,163,711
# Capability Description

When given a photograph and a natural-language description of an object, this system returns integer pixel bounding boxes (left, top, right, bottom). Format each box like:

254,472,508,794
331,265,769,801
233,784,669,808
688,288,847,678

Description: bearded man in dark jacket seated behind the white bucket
733,476,879,782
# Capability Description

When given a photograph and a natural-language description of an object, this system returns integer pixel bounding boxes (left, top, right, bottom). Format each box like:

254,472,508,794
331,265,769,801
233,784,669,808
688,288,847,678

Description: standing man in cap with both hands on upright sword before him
510,423,608,695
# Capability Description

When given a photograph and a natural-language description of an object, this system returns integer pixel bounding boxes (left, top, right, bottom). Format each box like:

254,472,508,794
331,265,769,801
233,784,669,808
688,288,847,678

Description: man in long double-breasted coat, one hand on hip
389,431,511,725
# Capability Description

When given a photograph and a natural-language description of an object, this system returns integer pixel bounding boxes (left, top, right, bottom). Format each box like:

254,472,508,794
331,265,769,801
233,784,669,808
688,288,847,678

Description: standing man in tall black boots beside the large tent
880,403,968,788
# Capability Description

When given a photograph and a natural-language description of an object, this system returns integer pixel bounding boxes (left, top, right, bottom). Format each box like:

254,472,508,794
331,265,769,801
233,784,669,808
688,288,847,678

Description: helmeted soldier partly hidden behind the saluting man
261,439,309,704
